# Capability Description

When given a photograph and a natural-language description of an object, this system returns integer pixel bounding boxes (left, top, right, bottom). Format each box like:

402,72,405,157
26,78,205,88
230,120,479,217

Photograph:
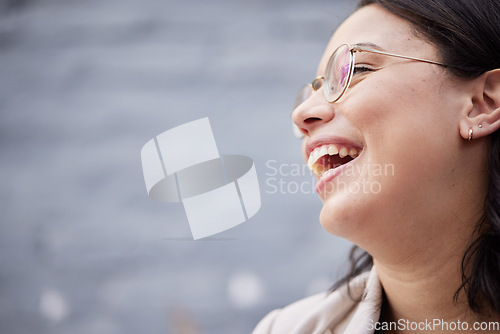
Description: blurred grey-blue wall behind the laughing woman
0,0,355,334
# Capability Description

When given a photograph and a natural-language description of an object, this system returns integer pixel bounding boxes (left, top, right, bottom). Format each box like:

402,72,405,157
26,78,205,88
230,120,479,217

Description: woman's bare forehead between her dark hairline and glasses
318,4,436,73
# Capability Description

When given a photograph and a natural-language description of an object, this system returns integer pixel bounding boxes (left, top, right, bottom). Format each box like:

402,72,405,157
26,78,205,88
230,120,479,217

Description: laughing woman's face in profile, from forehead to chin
293,5,478,250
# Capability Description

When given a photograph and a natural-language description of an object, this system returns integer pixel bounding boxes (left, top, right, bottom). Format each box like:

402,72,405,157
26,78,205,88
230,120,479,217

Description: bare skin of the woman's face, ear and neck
292,5,500,333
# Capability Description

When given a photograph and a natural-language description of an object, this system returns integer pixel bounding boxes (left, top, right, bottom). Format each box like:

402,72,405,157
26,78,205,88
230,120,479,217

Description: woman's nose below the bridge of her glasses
292,90,335,136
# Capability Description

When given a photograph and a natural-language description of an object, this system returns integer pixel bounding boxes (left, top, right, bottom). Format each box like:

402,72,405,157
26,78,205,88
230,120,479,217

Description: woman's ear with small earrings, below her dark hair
459,69,500,139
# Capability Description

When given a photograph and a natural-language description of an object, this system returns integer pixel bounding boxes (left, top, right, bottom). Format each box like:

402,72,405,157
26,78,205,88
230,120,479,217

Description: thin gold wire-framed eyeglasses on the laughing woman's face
294,44,450,138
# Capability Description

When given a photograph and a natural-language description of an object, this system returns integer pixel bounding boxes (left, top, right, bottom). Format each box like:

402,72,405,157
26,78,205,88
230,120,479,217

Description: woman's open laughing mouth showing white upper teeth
307,144,362,177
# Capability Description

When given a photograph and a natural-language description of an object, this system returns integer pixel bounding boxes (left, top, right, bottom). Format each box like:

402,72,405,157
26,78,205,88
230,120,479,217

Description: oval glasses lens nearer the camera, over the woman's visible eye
325,44,351,102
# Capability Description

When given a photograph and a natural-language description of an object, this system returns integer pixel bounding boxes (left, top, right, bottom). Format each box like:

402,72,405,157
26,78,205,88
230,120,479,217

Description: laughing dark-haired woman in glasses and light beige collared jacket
254,0,500,334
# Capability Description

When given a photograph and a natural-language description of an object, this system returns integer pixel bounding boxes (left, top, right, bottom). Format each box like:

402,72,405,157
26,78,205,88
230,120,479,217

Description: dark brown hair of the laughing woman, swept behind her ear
332,0,500,314
